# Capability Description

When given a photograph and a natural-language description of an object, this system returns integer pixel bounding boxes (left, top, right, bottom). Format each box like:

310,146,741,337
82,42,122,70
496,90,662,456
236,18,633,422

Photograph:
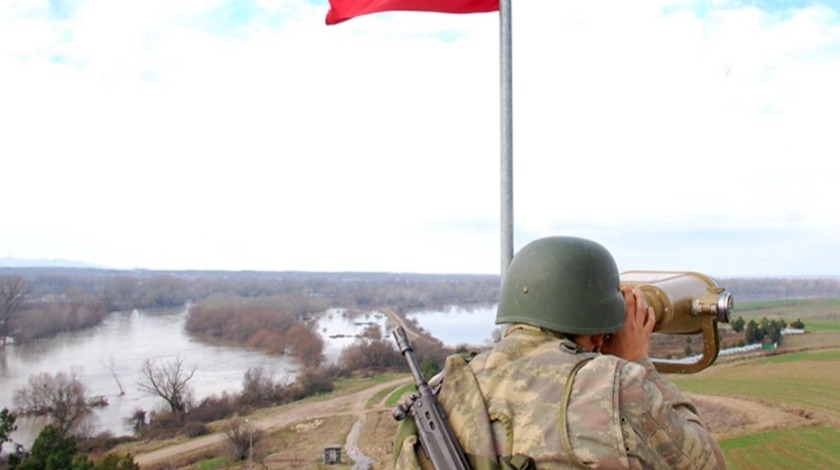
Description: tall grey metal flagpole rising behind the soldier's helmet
499,0,513,279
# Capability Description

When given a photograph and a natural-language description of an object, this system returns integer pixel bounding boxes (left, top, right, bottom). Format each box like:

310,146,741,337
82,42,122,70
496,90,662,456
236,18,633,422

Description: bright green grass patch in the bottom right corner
720,426,840,470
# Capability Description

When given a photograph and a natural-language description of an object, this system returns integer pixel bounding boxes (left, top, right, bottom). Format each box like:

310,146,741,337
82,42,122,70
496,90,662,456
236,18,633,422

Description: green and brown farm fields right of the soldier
671,299,840,469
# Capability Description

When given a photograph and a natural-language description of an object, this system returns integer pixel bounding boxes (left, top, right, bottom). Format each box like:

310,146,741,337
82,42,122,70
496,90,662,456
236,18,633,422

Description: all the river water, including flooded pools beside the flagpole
0,307,495,446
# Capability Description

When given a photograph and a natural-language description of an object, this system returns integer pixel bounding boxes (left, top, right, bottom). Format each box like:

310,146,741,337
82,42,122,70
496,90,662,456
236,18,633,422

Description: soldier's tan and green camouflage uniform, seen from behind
395,324,725,469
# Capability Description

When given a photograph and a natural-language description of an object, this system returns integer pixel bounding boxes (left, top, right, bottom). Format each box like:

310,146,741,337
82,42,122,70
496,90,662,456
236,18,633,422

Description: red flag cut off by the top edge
327,0,499,24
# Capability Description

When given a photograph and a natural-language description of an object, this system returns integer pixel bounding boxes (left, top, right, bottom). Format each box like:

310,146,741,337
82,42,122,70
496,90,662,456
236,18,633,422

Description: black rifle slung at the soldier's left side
393,326,470,470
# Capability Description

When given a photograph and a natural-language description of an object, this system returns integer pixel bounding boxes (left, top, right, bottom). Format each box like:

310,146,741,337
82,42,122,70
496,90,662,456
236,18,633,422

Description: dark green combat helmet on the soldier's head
496,237,624,335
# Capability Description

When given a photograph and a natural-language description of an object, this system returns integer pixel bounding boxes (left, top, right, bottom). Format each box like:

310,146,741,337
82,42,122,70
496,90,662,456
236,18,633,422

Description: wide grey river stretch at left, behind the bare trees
0,309,298,450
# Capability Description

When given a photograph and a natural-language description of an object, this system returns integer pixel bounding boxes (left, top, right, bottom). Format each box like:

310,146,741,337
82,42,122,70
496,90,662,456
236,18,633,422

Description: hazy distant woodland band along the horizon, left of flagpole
0,268,499,345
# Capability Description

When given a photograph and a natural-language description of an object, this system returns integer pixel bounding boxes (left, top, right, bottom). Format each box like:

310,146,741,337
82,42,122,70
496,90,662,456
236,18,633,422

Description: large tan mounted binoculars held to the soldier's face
621,271,734,374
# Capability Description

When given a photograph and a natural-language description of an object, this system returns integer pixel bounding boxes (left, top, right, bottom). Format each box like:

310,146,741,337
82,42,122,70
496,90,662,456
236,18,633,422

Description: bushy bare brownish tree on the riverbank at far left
14,372,90,434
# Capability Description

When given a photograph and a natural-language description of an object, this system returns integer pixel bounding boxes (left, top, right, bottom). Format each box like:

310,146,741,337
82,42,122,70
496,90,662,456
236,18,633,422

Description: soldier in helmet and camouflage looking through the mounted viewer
395,237,725,469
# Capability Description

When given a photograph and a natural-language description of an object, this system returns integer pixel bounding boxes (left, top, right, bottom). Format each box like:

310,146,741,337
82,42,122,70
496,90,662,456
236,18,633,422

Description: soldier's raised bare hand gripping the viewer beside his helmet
601,286,656,361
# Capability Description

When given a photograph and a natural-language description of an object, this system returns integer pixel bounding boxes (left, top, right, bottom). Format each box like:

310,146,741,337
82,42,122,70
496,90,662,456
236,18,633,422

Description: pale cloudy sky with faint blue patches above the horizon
0,0,840,277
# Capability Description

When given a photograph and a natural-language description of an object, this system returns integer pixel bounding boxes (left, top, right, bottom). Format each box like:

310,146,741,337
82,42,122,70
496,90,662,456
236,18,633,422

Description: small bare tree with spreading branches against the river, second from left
137,357,195,414
